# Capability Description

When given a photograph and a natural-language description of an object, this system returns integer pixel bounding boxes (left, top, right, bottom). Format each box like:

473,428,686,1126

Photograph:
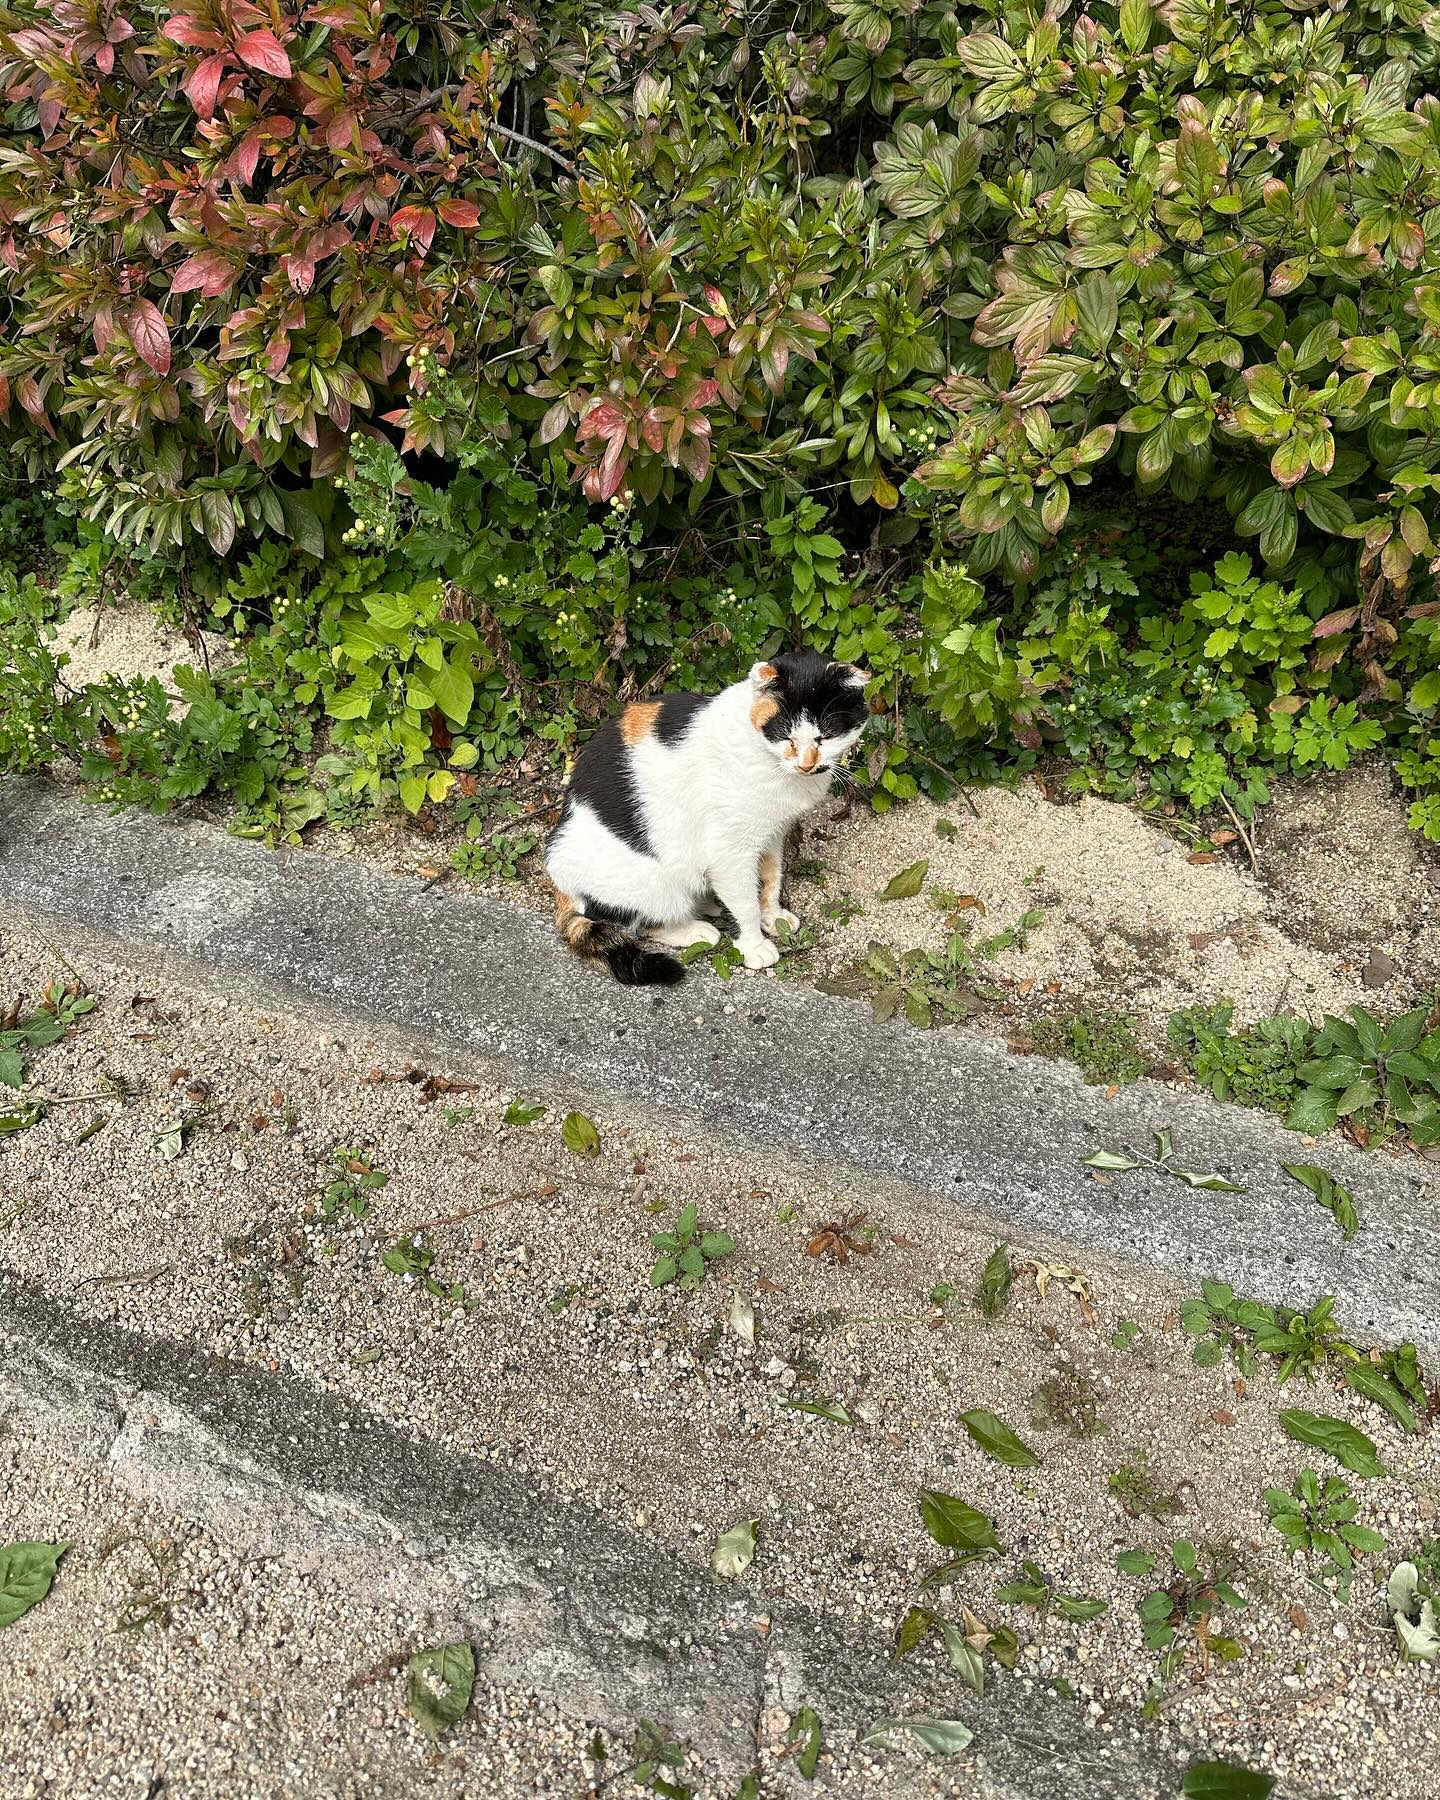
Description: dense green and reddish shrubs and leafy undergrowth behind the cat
0,0,1440,842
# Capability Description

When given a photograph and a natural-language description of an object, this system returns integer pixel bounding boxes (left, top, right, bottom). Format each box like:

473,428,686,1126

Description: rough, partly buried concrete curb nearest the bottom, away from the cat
0,1276,1195,1800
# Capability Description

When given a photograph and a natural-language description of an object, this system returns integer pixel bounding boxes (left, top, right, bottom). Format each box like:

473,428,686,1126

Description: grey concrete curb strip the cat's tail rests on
0,781,1440,1354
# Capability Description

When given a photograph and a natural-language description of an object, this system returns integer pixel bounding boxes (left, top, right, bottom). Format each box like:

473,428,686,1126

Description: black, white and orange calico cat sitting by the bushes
545,650,869,983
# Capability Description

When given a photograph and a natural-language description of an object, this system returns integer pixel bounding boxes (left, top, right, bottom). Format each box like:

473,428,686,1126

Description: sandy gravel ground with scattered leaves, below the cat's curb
0,921,1440,1800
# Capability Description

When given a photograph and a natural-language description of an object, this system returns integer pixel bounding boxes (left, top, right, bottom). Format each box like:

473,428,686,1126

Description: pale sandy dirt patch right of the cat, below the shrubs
790,769,1440,1044
